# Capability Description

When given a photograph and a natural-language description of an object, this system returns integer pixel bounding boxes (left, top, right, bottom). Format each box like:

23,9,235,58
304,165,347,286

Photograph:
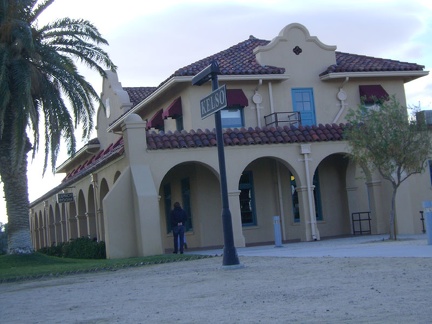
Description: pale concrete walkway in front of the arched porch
185,234,432,258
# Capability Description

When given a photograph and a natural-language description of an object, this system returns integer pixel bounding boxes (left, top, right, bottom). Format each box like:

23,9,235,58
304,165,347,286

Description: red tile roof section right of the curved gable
320,52,424,76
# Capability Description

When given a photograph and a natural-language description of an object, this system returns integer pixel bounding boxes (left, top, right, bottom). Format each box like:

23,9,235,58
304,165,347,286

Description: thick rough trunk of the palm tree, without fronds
0,141,33,254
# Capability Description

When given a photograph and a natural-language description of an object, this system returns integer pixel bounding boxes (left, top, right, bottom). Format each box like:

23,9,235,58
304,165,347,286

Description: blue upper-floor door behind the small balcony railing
291,88,316,126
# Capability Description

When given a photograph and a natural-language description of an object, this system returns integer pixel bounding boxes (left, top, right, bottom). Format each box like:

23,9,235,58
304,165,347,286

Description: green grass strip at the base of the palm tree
0,252,213,283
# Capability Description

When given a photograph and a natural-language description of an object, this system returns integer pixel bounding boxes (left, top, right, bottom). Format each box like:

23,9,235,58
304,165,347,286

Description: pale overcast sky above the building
0,0,432,223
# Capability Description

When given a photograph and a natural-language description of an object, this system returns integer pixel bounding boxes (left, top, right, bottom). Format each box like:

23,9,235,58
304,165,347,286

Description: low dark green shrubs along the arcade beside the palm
38,237,106,259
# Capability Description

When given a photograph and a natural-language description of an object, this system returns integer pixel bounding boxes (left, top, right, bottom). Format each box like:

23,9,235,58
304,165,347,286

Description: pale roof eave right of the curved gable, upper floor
320,71,429,82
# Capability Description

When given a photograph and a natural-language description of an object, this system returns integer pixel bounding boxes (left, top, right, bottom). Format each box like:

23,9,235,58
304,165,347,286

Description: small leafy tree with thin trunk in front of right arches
345,96,432,240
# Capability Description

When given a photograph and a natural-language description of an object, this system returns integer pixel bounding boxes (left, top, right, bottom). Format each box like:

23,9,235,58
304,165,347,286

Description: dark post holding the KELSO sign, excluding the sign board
192,61,240,266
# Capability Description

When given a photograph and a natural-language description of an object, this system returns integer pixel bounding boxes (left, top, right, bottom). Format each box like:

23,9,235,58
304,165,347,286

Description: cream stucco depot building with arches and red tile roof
29,23,431,258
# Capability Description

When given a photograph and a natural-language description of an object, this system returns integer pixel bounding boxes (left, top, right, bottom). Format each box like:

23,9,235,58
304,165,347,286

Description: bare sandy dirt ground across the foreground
0,256,432,324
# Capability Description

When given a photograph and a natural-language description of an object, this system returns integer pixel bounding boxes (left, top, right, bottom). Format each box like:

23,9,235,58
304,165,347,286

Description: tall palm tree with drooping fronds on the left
0,0,116,254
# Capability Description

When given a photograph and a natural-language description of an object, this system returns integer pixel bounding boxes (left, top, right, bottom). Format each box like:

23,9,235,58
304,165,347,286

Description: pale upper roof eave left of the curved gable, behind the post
107,74,289,132
